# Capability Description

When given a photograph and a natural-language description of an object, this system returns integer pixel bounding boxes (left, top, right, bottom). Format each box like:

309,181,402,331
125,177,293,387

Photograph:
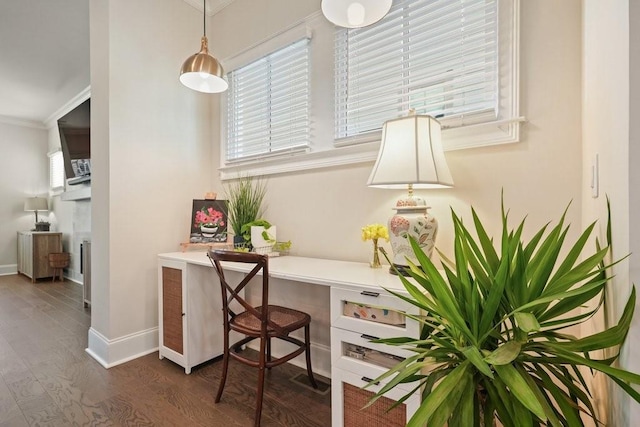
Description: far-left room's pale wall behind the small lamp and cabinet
0,122,49,274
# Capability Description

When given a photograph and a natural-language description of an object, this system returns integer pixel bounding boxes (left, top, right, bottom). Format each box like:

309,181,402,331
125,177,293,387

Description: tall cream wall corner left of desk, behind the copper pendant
89,0,213,366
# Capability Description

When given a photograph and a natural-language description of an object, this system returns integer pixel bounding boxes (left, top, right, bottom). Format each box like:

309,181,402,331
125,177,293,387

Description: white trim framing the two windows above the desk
219,0,524,180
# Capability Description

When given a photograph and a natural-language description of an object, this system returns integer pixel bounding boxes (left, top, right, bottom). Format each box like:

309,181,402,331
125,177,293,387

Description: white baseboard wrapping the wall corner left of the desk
86,328,158,369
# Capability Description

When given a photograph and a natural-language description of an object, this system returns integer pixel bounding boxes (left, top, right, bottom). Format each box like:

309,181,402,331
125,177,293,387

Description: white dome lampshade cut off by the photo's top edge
321,0,392,28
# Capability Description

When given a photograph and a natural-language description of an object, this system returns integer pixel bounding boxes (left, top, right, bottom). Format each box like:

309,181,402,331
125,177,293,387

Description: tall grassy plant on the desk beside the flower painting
225,176,267,243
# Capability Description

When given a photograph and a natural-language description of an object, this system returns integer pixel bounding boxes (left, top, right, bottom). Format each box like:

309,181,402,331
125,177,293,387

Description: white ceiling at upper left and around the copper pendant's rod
0,0,233,125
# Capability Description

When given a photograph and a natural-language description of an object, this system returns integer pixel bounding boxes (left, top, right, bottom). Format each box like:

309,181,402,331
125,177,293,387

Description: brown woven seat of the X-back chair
229,305,311,335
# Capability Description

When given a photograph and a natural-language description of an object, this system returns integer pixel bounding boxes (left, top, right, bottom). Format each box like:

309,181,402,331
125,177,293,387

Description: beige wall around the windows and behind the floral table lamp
210,0,582,262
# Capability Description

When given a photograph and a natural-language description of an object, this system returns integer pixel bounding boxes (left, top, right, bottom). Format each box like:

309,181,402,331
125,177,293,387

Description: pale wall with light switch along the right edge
583,0,640,426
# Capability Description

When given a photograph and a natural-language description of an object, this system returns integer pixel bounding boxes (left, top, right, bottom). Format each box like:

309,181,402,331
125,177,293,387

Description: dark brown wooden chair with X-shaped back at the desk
208,250,318,427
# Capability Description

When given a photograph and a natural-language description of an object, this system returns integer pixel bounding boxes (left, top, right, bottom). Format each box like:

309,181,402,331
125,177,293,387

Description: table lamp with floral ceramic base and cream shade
367,110,453,274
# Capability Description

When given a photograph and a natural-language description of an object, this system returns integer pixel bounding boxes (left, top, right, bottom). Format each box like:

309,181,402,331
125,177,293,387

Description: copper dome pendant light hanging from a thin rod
180,0,229,93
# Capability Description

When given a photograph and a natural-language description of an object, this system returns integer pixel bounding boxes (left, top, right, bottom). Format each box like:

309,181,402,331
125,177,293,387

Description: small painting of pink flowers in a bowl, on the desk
189,199,228,243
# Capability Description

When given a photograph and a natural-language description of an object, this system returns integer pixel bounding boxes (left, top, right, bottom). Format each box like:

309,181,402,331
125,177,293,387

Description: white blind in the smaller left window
225,38,310,163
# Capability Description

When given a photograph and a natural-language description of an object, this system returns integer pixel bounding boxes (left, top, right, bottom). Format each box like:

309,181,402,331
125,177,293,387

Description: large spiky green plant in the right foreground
372,201,640,427
